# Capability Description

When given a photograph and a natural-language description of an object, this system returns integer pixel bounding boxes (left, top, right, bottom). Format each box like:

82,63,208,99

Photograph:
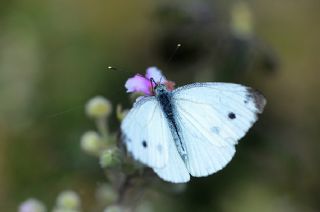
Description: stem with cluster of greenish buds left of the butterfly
80,96,141,211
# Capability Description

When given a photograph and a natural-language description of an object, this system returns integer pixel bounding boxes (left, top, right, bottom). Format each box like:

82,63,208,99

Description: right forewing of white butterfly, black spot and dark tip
173,83,265,146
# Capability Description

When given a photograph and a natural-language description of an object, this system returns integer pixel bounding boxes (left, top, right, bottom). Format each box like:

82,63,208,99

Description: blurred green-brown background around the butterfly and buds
0,0,320,212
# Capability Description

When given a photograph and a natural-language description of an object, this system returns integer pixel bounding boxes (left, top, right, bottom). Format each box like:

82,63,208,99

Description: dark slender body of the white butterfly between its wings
154,84,187,160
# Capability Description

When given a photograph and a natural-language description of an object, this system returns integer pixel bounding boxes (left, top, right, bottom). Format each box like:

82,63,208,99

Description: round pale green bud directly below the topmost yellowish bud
80,131,102,155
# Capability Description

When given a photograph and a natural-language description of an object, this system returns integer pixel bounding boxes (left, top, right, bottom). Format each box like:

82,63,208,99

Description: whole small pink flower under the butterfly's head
125,67,175,96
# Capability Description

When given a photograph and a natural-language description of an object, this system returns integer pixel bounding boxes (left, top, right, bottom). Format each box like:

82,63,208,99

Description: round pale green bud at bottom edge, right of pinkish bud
56,191,80,210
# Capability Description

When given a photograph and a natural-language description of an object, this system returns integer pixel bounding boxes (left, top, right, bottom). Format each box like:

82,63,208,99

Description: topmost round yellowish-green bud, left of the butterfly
86,96,112,118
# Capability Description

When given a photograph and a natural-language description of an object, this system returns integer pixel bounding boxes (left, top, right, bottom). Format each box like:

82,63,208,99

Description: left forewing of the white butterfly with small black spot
121,97,171,168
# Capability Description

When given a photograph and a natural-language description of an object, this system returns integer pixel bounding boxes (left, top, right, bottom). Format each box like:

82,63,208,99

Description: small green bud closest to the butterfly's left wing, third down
100,147,121,168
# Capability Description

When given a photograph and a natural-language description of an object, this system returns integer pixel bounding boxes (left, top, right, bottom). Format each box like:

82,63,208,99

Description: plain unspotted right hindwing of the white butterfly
172,102,235,177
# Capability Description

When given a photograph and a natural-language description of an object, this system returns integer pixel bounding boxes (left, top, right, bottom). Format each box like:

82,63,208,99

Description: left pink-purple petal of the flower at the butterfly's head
124,75,151,95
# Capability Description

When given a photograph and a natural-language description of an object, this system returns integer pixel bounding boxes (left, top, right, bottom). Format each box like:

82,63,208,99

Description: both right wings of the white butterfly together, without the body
173,83,265,177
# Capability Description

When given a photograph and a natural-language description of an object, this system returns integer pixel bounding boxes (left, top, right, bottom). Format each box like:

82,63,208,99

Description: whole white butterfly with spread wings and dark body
121,82,266,183
